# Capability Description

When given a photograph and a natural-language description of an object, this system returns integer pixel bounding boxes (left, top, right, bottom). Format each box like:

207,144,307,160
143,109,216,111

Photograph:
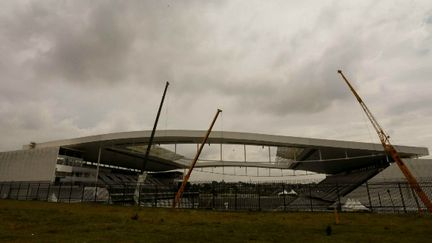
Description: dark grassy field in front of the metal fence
0,200,432,243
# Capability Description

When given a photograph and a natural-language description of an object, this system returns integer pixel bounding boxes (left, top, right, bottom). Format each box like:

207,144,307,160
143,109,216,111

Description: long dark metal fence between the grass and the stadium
0,182,432,213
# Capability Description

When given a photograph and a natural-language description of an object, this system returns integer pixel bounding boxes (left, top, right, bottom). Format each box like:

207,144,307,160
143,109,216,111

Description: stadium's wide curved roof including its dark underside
23,130,429,174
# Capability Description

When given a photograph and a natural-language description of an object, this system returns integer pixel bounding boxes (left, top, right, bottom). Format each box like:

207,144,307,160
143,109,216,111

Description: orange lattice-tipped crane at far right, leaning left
338,70,432,214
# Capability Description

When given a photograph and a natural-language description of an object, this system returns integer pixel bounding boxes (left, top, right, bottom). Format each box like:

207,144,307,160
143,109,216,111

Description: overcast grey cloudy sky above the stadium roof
0,0,432,159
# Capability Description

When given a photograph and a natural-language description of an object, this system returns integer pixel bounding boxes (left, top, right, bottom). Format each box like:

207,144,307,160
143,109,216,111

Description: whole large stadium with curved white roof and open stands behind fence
0,130,431,210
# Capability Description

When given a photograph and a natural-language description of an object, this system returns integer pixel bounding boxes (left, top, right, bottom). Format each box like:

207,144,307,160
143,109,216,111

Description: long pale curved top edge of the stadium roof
26,130,429,156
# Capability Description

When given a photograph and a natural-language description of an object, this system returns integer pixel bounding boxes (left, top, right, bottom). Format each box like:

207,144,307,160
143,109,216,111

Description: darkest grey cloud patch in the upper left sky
35,2,134,82
